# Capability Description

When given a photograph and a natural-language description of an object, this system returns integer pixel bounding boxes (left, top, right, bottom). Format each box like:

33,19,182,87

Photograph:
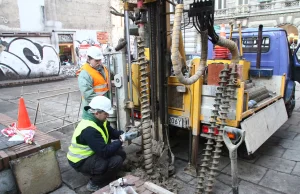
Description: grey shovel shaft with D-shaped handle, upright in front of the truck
223,126,245,194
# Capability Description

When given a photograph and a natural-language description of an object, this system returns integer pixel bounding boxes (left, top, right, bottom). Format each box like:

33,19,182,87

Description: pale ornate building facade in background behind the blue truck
180,0,300,55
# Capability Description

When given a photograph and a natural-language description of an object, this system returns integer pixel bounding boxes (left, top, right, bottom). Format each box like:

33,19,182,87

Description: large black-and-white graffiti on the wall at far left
0,38,60,79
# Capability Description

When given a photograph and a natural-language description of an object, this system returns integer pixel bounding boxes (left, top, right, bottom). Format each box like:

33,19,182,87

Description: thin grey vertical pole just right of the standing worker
124,2,134,126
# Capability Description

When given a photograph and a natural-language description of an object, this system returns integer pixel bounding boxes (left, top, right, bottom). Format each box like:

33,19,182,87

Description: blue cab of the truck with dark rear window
208,28,300,117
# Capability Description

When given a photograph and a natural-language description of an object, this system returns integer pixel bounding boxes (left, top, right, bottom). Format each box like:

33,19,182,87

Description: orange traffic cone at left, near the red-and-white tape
17,97,36,130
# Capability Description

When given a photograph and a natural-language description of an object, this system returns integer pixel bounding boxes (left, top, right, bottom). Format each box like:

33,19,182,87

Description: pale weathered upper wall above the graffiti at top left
0,0,124,46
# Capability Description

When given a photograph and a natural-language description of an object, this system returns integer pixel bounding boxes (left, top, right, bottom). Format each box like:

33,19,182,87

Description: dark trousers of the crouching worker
77,149,126,186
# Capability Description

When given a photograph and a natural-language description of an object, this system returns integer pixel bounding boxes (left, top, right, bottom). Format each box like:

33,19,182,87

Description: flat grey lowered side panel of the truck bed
241,99,288,154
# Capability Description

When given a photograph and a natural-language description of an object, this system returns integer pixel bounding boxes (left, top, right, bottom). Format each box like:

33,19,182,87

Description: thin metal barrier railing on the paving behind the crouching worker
8,82,82,133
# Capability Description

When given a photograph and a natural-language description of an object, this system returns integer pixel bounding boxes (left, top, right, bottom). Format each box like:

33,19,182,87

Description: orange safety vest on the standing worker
78,63,109,96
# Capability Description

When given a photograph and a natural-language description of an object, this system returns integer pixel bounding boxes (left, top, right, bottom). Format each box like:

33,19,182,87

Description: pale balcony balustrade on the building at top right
215,0,300,19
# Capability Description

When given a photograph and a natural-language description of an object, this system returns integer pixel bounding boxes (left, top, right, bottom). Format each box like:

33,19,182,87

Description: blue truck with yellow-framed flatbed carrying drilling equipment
168,28,300,157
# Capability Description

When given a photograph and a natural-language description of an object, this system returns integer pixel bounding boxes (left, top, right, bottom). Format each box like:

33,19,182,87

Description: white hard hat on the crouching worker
89,96,114,114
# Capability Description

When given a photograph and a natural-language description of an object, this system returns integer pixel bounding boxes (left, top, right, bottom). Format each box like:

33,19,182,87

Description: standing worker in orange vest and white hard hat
78,46,110,111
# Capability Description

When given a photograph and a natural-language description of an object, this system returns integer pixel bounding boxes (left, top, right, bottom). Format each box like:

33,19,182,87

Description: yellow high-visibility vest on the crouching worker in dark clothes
67,119,109,163
